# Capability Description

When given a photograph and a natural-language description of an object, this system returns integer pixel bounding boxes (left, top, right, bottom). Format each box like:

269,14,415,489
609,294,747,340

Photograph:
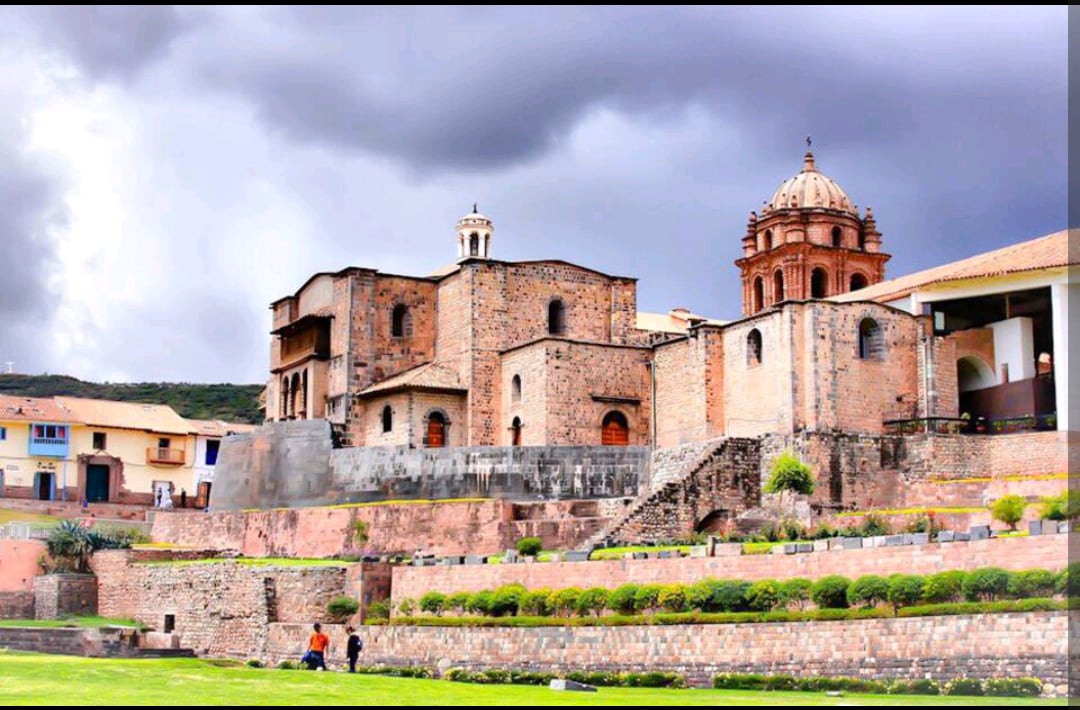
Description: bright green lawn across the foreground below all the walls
0,653,1066,706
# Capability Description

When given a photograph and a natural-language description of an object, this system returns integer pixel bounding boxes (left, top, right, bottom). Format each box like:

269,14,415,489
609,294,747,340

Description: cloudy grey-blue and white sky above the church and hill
0,6,1068,383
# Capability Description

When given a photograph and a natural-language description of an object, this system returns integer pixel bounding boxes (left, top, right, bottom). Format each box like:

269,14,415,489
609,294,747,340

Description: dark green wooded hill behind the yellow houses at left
0,375,262,424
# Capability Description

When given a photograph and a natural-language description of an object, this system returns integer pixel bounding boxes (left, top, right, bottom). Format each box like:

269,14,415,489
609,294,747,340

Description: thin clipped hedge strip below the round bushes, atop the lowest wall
367,599,1067,628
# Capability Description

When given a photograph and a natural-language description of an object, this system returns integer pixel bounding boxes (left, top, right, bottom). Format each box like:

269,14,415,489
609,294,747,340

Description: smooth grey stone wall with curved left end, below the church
211,420,649,510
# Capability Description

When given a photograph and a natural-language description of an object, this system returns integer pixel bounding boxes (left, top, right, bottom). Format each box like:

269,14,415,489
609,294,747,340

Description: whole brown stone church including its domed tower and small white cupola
267,152,957,447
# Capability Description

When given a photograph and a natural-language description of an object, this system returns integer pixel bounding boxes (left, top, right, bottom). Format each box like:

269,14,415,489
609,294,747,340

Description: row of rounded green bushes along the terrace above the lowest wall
401,563,1080,617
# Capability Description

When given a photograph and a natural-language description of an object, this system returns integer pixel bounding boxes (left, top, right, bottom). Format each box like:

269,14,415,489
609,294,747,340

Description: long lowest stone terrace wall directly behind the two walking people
265,612,1069,693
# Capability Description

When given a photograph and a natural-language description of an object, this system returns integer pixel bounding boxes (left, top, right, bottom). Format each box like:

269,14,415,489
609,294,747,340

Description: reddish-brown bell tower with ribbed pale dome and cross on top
735,143,890,316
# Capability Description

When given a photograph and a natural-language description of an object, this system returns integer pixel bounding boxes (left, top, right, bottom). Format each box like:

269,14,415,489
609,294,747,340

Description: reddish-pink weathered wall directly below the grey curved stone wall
151,499,619,558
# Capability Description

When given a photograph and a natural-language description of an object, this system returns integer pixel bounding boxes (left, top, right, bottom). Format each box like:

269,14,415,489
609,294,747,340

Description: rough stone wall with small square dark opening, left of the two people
93,550,347,658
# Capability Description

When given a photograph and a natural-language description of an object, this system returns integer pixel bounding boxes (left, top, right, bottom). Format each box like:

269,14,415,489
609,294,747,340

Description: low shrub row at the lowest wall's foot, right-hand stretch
713,673,1042,698
